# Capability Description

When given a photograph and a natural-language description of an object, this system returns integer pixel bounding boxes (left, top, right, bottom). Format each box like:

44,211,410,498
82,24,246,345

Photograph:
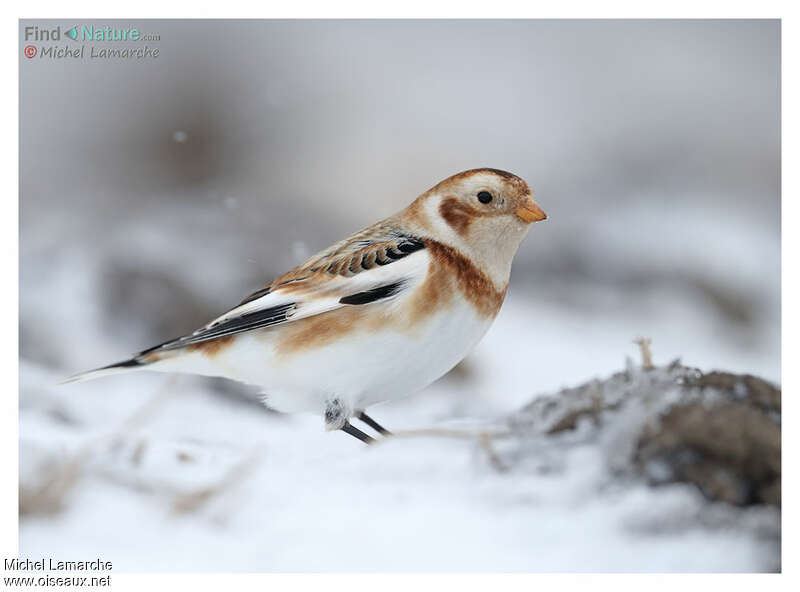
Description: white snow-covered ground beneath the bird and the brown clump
20,358,776,571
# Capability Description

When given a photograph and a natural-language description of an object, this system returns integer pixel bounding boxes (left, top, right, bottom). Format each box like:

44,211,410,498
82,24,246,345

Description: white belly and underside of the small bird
198,302,493,413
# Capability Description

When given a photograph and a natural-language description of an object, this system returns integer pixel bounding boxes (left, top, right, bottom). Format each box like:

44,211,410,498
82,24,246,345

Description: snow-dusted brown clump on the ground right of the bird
506,340,781,506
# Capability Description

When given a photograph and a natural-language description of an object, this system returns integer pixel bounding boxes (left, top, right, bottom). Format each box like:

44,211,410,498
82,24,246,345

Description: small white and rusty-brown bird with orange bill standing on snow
62,168,547,443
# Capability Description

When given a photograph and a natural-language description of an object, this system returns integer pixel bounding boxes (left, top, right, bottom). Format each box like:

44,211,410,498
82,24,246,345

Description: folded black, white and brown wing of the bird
140,228,428,355
